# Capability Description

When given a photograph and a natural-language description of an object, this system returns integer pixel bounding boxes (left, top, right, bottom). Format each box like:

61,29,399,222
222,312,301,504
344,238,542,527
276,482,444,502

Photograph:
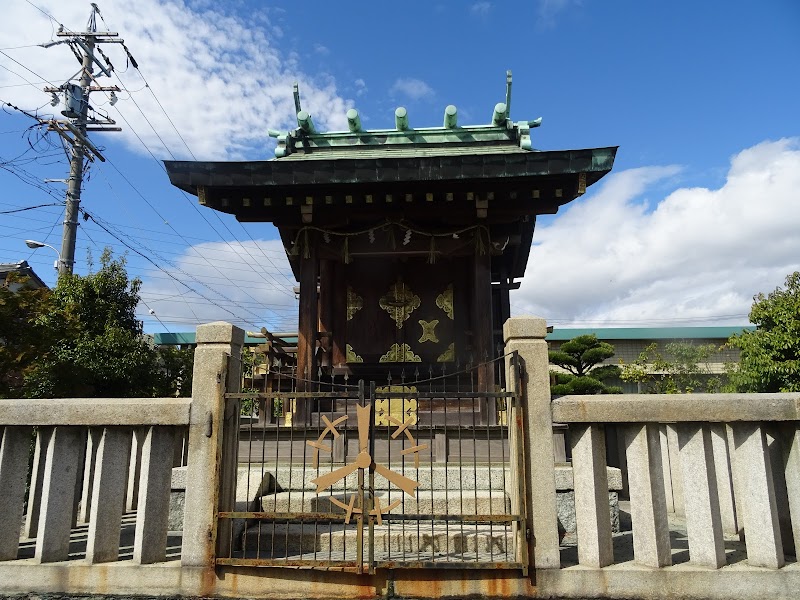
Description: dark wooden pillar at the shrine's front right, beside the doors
472,239,497,425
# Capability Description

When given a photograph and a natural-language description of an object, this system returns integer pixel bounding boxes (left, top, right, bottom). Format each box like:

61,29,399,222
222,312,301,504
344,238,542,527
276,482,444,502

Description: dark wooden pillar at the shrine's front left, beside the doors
295,241,319,423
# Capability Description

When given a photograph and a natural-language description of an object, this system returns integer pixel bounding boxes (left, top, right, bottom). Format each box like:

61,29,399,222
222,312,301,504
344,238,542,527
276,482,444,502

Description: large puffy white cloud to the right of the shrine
511,138,800,326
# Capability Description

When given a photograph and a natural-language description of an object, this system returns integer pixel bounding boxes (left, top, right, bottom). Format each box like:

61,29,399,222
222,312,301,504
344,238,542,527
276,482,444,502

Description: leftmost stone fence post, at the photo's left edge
0,426,33,560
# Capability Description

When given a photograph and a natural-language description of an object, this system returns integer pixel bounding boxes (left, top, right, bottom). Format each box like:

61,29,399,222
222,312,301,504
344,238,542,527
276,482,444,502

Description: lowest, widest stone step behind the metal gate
240,521,514,560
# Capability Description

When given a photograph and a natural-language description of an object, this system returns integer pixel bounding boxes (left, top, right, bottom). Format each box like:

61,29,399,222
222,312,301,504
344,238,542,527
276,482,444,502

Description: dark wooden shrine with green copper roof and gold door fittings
166,79,616,422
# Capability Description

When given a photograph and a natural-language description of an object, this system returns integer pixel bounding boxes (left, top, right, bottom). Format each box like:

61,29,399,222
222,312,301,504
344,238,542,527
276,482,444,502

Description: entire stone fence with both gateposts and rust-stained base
0,318,800,599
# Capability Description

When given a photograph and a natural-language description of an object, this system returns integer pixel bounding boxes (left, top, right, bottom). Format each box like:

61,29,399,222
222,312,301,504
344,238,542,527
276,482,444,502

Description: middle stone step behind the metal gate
261,490,511,515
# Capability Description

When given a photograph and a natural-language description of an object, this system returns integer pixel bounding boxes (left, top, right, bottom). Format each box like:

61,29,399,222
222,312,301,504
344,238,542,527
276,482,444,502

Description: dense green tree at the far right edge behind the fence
730,271,800,392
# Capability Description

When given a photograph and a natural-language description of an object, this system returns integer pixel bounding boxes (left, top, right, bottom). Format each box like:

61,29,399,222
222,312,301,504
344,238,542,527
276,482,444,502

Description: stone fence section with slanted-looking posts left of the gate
0,398,191,563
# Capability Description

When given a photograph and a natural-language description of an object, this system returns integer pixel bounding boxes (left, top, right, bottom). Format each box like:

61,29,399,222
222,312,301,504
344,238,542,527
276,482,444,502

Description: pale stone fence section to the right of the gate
536,394,800,597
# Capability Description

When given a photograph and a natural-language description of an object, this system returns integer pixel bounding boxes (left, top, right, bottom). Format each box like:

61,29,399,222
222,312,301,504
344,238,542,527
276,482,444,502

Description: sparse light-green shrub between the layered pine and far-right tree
620,341,724,394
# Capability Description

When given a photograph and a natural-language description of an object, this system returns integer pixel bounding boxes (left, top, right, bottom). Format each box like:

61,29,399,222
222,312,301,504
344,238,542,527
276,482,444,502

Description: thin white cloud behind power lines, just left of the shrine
140,240,297,331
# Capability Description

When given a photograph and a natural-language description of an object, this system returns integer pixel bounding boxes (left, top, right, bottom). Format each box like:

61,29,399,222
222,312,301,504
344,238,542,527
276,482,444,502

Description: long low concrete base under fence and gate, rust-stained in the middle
0,561,800,600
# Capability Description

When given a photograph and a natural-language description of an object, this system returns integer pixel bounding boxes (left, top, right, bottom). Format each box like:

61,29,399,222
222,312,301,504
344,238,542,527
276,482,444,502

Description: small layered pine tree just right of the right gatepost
548,334,622,396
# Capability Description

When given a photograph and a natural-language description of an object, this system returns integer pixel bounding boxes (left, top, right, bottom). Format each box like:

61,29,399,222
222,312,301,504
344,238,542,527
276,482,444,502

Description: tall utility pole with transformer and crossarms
42,3,127,275
